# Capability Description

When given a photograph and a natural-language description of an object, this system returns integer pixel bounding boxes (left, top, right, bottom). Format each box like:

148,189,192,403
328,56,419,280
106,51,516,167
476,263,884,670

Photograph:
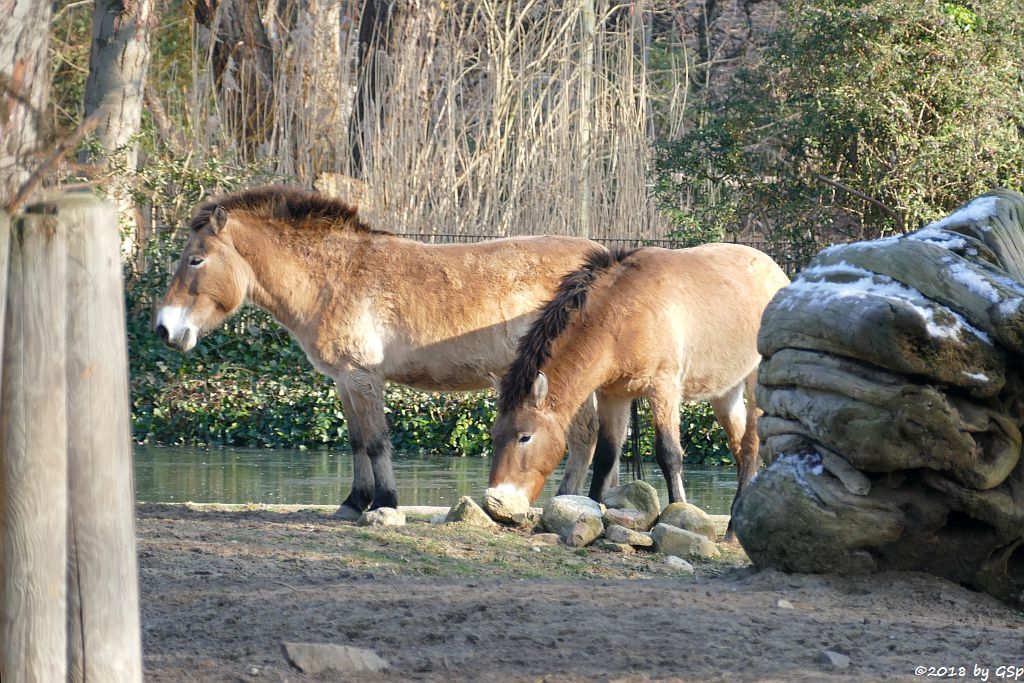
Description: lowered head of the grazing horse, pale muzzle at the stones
490,373,565,502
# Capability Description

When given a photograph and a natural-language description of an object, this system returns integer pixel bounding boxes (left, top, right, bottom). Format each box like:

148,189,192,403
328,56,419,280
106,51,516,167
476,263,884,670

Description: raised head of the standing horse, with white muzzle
156,205,252,351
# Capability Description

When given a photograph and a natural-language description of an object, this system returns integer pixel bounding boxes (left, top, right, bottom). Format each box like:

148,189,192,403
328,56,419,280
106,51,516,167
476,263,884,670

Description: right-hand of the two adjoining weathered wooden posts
61,195,142,683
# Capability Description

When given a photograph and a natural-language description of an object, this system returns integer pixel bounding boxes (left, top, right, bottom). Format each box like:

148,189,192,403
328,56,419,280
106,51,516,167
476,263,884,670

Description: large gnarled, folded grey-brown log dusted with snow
734,190,1024,606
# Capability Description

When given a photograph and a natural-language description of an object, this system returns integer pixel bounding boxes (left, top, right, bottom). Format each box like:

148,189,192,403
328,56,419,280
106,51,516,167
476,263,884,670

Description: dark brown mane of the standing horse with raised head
189,185,387,234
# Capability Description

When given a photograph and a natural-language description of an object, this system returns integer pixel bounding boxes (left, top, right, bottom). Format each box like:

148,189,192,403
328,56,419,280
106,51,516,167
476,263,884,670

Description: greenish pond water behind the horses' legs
135,445,736,514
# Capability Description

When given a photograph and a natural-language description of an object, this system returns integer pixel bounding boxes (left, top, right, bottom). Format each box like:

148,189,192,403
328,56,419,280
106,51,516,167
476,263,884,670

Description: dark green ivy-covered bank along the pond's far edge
128,282,731,465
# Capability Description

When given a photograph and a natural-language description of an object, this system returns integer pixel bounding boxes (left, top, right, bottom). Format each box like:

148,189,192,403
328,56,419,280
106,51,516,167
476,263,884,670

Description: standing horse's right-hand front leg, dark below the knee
341,371,398,510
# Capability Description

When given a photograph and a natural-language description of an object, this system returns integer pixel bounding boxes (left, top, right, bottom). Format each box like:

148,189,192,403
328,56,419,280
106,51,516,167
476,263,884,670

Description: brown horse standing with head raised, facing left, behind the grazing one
156,186,603,516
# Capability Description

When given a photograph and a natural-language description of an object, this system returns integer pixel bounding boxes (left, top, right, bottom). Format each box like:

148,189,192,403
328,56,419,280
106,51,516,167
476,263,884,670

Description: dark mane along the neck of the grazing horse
498,249,636,413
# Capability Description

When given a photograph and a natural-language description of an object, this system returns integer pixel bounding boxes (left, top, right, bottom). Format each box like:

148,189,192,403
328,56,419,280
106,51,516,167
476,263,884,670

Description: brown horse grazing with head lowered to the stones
490,244,788,528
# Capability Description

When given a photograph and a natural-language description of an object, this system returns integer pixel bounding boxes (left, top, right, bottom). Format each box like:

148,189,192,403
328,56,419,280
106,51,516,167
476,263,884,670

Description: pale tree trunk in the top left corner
0,0,50,206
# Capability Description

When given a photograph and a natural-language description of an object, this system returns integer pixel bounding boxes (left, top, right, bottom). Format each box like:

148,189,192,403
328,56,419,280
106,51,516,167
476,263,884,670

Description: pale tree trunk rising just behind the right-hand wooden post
82,0,155,172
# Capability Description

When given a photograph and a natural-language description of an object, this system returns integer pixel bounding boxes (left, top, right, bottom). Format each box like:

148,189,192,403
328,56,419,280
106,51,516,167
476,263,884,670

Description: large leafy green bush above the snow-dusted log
657,0,1024,250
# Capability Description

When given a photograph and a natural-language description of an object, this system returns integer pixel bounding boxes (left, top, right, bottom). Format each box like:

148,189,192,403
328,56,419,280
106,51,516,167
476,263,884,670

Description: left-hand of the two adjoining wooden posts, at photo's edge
0,204,68,683
